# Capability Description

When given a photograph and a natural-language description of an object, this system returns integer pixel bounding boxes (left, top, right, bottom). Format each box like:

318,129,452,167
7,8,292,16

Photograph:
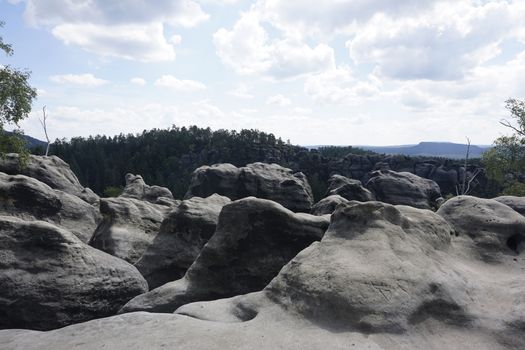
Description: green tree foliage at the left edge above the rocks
0,22,36,163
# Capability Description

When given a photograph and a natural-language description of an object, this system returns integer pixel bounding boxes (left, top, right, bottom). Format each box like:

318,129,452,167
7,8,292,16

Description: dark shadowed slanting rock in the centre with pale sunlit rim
121,197,328,312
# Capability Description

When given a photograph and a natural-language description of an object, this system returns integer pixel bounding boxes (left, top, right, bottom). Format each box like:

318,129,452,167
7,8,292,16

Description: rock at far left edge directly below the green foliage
0,153,99,204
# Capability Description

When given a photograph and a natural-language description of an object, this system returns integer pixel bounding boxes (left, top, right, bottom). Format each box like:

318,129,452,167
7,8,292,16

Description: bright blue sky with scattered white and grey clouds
0,0,525,145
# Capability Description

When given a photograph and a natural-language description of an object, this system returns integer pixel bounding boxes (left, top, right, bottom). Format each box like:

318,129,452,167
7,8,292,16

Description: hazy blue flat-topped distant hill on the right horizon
358,142,490,159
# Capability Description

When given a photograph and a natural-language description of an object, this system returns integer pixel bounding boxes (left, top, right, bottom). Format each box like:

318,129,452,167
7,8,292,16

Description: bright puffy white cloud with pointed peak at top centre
213,12,335,79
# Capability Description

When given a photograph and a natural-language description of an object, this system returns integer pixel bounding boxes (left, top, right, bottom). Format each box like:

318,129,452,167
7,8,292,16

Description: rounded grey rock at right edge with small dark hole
437,196,525,261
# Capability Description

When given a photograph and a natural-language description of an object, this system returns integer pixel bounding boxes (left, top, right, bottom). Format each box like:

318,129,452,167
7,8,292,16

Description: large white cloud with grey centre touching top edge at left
17,0,209,62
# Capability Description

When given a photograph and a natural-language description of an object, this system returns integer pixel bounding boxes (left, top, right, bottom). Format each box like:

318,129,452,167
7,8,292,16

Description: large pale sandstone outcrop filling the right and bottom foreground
5,202,525,350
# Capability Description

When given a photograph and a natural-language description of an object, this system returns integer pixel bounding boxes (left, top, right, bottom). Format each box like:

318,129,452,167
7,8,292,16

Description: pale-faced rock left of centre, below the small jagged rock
89,197,172,264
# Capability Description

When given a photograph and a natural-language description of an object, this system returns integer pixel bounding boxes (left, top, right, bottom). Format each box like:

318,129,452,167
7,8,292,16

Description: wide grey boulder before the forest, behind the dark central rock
186,163,313,212
